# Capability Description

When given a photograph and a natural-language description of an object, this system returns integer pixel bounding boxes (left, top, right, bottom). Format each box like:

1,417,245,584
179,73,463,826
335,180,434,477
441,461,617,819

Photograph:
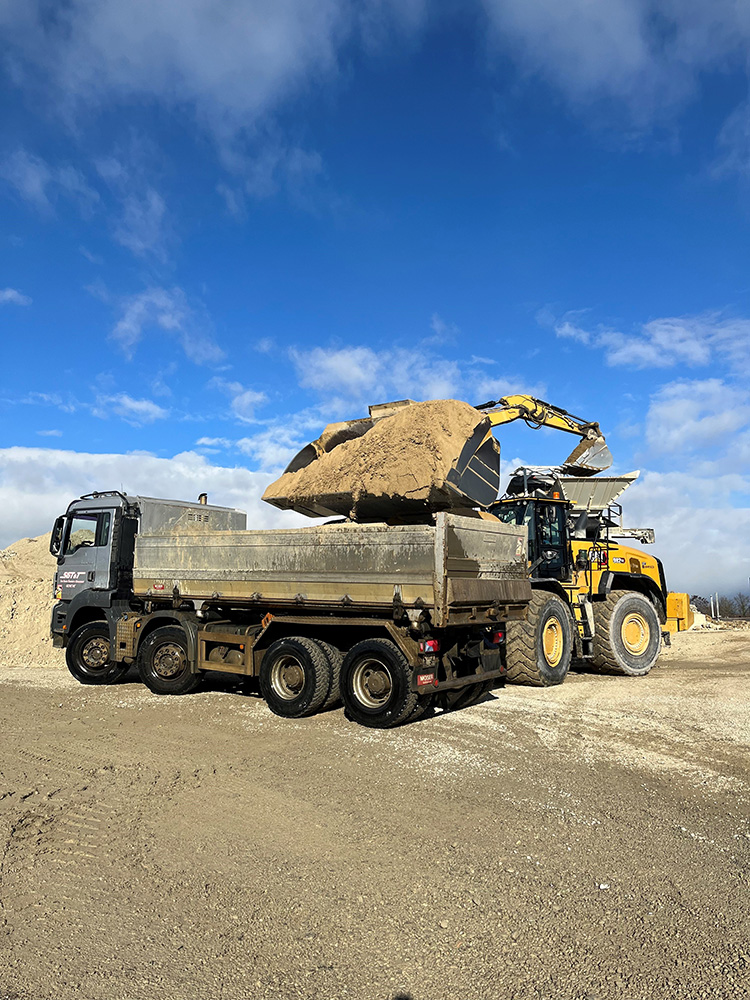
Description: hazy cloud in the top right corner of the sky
482,0,750,126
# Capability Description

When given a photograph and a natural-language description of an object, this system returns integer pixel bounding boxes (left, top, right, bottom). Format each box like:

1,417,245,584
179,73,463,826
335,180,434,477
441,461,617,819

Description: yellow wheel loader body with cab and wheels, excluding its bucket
489,469,667,686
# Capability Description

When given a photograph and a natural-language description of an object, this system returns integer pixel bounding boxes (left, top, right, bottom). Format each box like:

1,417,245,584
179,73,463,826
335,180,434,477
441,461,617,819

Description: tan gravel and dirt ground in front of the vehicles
0,632,750,1000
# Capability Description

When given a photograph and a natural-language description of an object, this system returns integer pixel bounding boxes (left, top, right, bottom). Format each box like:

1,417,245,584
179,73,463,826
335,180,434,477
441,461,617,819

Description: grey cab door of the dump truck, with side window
57,510,114,601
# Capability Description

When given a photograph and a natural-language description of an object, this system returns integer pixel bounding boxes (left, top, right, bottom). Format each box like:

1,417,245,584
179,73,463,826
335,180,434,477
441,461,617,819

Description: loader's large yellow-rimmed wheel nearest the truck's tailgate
505,590,573,687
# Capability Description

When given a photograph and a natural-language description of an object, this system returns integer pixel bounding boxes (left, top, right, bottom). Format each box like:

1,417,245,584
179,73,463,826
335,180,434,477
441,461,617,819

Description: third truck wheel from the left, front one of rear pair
260,636,331,719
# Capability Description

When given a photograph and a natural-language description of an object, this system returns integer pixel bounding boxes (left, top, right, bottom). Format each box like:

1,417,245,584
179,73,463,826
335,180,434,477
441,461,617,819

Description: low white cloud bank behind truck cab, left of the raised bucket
0,448,312,547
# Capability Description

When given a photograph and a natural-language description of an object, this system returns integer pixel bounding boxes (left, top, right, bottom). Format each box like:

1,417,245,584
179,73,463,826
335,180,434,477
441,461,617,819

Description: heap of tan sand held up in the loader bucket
263,399,496,519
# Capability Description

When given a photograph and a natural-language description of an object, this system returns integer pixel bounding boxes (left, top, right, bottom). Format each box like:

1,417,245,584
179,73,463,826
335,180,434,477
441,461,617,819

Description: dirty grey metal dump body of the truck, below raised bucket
133,513,531,627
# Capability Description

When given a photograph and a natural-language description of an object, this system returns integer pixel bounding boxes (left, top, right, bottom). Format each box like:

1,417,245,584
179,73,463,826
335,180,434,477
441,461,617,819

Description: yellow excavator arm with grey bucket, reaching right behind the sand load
476,394,612,476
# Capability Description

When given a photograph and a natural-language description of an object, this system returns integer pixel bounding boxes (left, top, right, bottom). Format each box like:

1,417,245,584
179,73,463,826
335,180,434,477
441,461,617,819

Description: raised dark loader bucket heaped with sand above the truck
263,400,500,521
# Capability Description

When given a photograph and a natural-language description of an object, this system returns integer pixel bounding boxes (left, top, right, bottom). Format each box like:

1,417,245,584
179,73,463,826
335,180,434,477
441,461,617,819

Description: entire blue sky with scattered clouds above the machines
0,0,750,592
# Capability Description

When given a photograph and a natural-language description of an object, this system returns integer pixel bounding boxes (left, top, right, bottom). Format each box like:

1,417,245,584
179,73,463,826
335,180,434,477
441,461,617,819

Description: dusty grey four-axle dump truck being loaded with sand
50,492,531,728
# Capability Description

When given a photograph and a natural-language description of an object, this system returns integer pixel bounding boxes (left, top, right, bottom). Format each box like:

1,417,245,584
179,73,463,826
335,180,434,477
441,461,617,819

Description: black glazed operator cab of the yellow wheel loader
490,497,572,580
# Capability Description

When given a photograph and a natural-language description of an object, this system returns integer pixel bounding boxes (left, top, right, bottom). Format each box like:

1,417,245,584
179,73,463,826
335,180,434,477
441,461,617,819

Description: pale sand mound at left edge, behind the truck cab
0,535,65,667
